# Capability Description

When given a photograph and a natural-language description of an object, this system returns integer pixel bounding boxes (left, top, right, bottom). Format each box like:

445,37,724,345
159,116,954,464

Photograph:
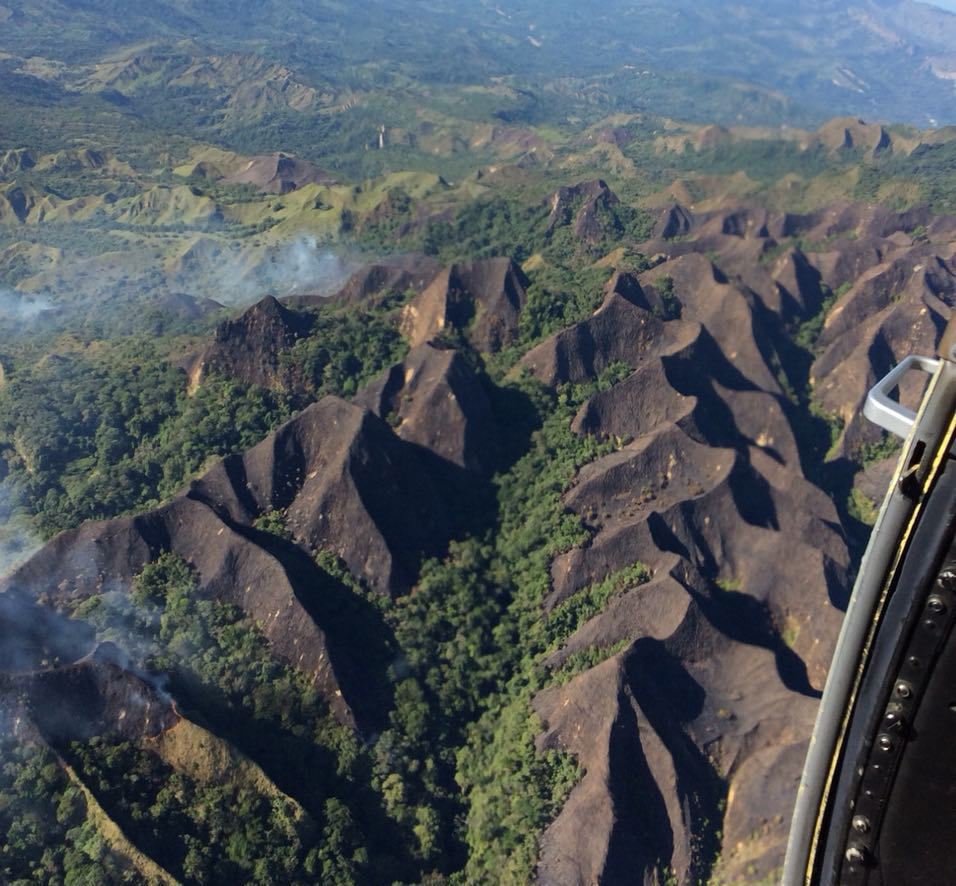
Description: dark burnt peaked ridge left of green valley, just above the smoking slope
5,397,460,722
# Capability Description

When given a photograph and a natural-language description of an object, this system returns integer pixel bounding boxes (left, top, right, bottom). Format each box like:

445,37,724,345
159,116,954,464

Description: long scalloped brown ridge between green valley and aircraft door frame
526,268,849,886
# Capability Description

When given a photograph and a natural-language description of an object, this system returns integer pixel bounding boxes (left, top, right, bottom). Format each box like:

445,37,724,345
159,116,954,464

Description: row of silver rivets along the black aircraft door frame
841,565,956,886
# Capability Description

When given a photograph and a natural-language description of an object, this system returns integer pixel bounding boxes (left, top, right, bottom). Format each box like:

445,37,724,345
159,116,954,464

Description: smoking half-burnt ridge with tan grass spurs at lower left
0,632,316,886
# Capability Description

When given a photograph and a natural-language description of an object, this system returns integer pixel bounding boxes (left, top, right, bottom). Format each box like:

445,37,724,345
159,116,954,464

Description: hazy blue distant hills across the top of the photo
0,0,956,126
